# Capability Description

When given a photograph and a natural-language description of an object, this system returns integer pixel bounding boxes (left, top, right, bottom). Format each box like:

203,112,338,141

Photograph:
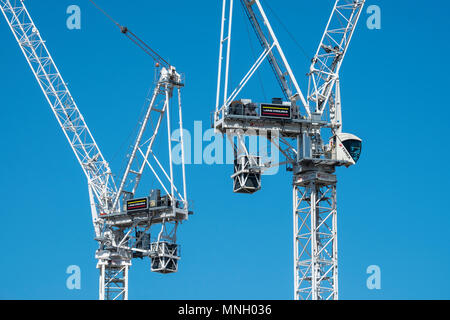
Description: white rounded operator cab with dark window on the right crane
330,133,362,167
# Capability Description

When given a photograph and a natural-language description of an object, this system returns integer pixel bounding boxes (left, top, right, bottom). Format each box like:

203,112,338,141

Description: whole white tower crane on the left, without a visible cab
0,0,192,300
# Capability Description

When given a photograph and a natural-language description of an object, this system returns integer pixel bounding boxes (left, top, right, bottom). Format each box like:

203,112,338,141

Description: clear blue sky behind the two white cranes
0,0,450,299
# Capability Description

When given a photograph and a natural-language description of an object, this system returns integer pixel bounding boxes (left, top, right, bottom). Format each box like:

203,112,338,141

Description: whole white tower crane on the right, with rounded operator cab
213,0,365,300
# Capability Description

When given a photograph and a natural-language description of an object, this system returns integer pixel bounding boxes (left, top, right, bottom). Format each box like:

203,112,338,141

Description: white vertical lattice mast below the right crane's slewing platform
293,181,338,300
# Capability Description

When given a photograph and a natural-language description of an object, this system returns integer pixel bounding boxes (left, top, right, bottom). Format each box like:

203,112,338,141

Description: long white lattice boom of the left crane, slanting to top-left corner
0,0,116,222
